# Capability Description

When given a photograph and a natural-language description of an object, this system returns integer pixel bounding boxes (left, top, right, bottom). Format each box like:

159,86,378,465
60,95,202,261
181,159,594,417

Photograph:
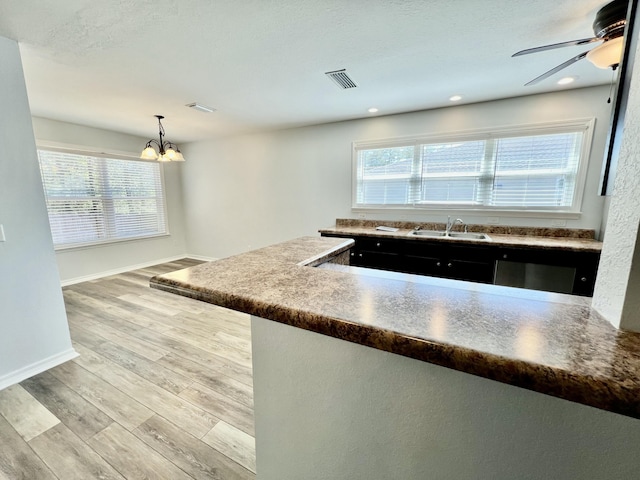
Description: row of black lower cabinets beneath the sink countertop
323,233,600,296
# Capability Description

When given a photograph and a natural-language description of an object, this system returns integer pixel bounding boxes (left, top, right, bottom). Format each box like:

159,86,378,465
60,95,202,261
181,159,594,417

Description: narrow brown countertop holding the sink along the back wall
319,219,602,253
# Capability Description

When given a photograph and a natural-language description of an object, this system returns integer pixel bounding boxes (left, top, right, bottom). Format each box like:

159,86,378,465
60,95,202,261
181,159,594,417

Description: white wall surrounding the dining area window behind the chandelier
33,117,187,283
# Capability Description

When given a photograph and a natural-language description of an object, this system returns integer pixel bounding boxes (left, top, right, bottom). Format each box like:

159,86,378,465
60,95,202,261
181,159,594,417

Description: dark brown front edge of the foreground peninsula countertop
151,280,640,418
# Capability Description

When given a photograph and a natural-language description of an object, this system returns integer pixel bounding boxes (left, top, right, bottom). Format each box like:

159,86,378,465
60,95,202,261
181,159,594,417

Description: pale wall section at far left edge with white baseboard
0,37,75,389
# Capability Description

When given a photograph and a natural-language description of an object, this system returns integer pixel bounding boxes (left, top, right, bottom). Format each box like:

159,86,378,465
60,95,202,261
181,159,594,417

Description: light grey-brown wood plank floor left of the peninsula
0,259,255,480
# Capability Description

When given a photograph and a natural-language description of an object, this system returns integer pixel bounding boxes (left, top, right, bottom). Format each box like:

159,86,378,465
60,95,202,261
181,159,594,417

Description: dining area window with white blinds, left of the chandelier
38,150,167,249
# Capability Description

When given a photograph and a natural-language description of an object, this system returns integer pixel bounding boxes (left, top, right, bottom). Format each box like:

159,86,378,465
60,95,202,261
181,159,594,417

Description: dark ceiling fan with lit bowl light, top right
512,0,634,86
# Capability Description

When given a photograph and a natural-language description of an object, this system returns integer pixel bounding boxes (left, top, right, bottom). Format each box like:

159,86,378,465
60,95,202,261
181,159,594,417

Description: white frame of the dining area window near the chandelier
36,141,171,251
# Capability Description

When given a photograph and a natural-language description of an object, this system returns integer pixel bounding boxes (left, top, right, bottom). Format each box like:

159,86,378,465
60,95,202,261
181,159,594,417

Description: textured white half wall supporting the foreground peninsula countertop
251,317,640,480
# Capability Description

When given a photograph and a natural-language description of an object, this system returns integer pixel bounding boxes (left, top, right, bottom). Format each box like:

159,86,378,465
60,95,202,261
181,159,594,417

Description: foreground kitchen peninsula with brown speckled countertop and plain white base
151,237,640,480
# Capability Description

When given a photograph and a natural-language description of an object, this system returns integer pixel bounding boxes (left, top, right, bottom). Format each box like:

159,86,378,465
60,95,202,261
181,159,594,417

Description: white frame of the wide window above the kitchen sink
351,118,596,218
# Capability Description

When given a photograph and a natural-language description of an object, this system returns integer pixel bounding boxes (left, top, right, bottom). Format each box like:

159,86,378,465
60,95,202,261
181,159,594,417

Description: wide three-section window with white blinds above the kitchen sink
353,121,593,211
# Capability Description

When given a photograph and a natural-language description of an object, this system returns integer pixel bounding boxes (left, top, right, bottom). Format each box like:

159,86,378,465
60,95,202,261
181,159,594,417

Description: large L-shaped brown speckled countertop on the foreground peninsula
151,237,640,418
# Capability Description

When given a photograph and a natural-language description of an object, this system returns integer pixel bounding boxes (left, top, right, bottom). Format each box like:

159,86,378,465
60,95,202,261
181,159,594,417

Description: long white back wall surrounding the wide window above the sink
183,86,610,257
